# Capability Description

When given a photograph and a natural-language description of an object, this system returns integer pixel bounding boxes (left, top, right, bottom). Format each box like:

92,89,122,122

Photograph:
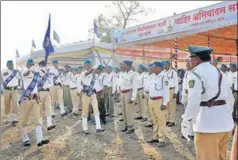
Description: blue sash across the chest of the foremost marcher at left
18,72,39,104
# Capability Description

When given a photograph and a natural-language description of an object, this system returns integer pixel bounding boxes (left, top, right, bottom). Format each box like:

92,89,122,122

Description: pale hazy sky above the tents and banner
1,1,221,68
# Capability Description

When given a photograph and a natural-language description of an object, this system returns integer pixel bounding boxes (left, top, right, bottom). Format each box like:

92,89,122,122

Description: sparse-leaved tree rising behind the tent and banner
89,1,154,43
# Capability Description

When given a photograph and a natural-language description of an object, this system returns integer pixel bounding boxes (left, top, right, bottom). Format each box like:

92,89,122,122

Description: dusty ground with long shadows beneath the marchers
0,95,232,160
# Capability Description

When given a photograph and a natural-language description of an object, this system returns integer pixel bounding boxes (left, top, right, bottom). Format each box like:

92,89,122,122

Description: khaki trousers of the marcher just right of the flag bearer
50,86,64,105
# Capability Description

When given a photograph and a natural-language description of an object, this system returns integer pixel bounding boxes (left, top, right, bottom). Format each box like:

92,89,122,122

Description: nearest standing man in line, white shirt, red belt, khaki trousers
148,62,169,147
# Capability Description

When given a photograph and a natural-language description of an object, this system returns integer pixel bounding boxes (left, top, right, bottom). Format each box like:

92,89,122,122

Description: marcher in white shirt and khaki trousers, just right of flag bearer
49,60,67,117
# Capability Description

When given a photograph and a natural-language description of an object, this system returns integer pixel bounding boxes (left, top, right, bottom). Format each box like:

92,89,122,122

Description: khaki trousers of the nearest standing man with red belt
149,99,166,142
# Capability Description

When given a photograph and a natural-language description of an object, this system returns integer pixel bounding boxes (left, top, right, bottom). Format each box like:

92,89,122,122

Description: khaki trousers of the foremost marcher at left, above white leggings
22,100,41,127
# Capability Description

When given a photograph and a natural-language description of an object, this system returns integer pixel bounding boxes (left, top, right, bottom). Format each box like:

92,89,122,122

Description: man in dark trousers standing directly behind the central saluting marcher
94,65,106,125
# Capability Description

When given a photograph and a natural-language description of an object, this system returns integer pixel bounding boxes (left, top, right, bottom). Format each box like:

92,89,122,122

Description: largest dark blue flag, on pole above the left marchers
43,15,54,65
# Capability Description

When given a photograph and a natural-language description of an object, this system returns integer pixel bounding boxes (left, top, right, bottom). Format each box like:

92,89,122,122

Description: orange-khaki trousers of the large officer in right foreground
194,132,230,160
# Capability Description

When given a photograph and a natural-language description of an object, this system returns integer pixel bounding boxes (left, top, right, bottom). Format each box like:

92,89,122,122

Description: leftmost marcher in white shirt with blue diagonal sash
2,60,20,126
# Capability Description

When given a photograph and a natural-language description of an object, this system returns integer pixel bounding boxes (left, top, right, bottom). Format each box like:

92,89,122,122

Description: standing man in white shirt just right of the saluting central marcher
120,60,138,134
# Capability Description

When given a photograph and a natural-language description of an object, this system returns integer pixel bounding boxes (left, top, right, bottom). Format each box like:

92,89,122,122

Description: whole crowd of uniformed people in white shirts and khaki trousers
2,46,238,160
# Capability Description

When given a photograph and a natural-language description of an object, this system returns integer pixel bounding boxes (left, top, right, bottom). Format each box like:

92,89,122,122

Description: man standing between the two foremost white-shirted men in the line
135,64,147,122
